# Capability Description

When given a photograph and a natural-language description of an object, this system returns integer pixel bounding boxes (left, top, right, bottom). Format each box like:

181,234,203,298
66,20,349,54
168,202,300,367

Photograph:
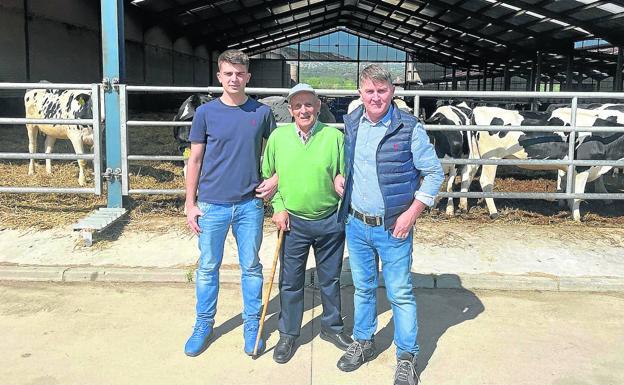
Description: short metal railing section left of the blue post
0,83,102,195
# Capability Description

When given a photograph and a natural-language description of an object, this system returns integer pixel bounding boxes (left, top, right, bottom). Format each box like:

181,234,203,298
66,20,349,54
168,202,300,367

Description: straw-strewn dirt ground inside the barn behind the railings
0,111,624,233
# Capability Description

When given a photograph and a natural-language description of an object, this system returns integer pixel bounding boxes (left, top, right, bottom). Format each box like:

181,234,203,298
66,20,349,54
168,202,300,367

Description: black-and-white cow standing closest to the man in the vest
425,102,472,215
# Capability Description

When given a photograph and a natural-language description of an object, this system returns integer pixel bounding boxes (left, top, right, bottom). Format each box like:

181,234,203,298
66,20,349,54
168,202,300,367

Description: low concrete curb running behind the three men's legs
0,266,624,292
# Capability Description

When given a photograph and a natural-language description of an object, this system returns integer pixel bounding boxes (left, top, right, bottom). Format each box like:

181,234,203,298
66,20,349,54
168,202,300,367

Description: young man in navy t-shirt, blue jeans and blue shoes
184,50,277,357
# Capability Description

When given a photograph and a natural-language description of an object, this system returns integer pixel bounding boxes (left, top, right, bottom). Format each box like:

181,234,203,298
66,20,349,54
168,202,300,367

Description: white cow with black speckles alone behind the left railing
24,89,93,186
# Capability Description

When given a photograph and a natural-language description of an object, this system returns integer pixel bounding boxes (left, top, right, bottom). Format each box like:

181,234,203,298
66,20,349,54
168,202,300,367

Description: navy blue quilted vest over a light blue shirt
338,105,420,230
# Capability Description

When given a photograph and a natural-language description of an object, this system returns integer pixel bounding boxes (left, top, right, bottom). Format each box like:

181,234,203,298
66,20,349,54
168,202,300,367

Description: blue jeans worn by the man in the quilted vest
346,215,419,357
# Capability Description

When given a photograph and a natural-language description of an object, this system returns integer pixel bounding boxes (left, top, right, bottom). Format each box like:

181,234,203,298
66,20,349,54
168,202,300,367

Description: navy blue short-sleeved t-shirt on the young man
189,98,277,203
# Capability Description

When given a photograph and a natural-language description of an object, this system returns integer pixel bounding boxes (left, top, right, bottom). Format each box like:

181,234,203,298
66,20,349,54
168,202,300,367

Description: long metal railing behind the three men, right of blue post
120,85,624,199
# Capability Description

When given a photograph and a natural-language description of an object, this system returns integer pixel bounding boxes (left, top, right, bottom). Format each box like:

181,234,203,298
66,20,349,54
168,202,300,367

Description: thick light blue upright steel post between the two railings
100,0,125,207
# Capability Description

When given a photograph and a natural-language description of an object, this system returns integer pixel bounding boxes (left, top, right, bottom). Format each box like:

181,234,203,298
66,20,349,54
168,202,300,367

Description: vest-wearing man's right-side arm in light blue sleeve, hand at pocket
392,123,444,238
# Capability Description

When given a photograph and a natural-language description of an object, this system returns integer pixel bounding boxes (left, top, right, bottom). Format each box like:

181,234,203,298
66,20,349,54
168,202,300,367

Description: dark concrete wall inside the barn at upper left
0,0,216,85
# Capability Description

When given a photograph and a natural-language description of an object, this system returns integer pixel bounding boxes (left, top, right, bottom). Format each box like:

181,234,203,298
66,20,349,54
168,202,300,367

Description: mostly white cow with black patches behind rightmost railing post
462,107,624,220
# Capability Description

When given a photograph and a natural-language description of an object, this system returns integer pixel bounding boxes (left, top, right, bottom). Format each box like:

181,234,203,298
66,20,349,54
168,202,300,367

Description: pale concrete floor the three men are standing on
0,282,624,385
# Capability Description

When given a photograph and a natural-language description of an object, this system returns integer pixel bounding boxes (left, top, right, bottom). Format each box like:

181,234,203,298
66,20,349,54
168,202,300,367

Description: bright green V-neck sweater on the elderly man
262,123,344,220
